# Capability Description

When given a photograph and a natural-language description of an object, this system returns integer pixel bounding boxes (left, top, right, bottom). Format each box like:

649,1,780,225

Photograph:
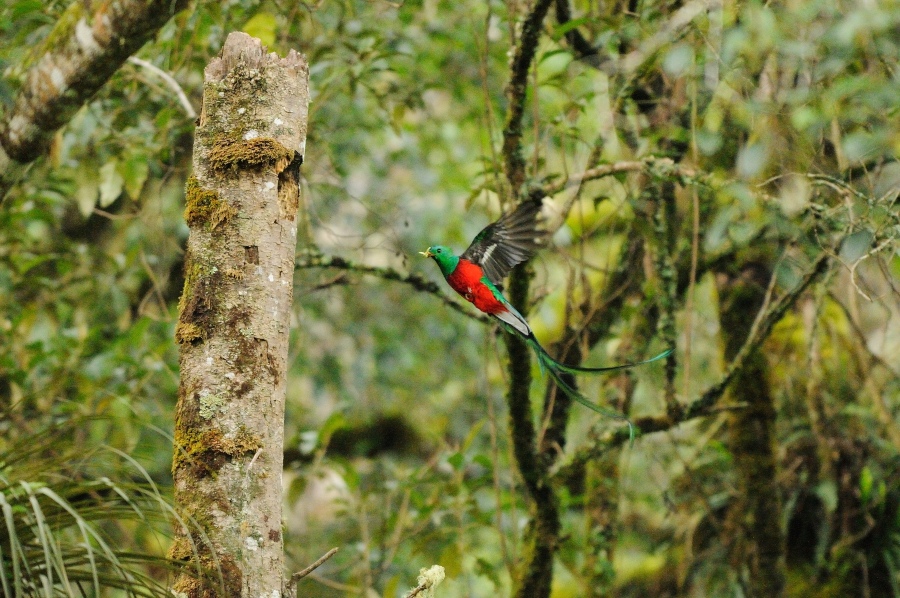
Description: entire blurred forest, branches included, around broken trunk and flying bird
0,0,900,598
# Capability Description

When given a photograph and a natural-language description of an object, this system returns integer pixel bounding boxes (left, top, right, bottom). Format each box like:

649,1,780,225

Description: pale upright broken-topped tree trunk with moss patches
171,33,309,598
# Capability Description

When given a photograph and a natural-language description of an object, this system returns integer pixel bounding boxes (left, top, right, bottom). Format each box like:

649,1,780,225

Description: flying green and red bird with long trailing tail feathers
419,199,672,427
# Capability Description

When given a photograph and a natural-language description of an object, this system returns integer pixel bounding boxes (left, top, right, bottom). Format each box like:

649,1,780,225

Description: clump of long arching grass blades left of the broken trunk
0,412,199,597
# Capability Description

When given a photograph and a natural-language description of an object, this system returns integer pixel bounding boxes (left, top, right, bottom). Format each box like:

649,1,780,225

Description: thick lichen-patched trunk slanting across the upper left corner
0,0,188,201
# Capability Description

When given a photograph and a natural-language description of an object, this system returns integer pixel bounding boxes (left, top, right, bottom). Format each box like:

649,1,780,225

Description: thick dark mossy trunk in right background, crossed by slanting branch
722,260,785,598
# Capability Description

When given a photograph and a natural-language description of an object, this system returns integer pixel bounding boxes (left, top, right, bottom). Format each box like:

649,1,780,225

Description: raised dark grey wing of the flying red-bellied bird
460,198,546,284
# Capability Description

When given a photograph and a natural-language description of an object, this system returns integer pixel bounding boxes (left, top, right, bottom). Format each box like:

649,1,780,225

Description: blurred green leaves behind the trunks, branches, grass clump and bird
0,0,900,597
